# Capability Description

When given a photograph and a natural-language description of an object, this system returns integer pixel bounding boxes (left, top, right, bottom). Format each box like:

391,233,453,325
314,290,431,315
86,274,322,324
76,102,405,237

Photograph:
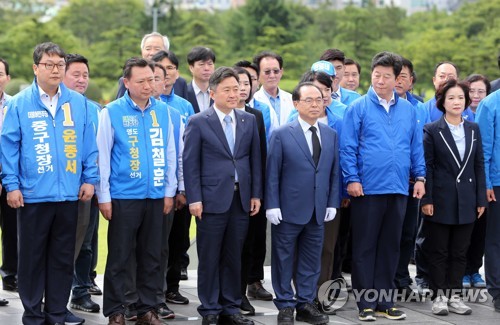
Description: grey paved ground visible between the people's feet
0,262,500,325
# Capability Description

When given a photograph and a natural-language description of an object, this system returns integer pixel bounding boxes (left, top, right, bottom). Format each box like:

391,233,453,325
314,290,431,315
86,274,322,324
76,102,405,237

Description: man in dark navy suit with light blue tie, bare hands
183,67,262,324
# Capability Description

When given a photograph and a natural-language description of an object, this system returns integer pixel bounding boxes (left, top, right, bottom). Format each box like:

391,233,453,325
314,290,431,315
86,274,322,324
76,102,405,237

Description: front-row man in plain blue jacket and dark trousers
340,52,425,321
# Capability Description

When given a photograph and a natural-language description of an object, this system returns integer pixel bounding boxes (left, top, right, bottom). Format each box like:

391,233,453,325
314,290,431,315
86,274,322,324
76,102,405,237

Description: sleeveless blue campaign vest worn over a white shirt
106,92,170,199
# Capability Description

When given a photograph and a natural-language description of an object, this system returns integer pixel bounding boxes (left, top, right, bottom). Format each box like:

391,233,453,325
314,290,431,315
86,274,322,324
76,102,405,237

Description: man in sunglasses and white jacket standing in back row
253,51,294,129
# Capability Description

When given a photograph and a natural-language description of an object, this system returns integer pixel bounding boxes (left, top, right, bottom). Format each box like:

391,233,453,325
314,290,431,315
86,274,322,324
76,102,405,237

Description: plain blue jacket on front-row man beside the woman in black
340,87,425,195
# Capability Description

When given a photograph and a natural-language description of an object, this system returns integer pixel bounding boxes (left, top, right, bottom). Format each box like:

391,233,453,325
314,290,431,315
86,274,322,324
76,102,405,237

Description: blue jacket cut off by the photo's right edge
476,90,500,189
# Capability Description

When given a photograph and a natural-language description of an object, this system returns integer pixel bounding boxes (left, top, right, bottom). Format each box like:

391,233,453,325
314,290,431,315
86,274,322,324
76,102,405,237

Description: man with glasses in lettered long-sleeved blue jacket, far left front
0,43,99,325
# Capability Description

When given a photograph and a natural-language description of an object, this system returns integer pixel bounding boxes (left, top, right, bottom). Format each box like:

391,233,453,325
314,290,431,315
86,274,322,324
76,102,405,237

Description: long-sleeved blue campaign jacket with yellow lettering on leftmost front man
1,79,99,203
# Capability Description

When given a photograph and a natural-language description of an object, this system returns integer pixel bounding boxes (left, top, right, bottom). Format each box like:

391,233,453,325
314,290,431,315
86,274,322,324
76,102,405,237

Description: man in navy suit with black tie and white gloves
265,82,340,324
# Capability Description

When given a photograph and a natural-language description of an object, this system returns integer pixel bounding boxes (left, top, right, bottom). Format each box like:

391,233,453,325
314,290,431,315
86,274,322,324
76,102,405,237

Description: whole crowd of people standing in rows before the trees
0,32,500,325
